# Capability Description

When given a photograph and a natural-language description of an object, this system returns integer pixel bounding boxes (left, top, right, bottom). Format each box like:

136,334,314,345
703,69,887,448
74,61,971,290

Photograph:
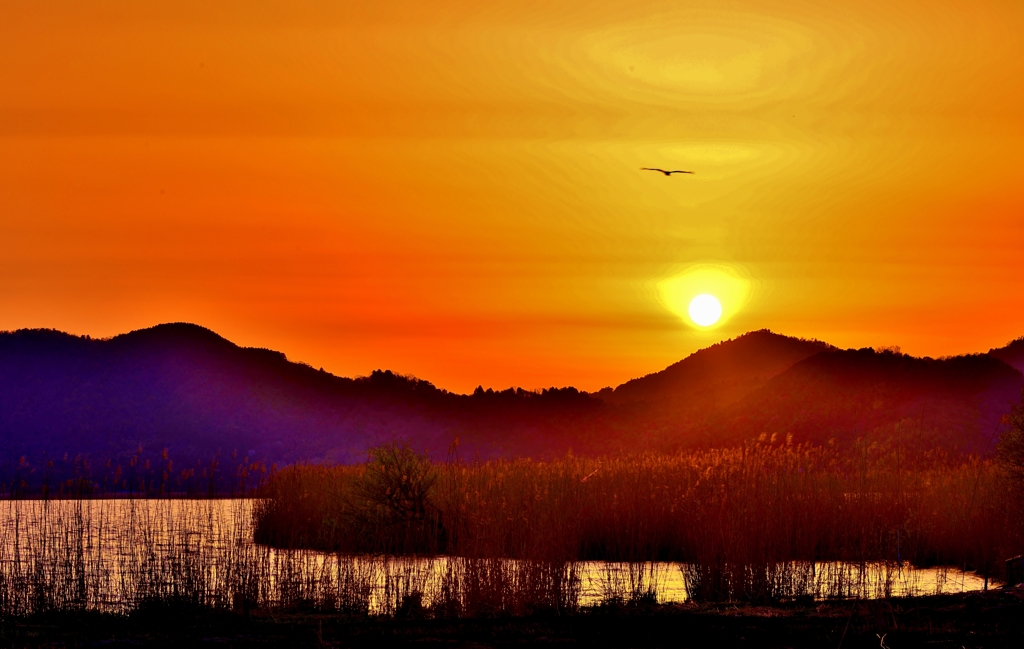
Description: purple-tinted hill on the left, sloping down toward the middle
0,323,601,463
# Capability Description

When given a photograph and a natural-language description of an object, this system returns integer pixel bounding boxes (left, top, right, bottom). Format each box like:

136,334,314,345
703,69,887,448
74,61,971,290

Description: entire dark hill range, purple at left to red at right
0,323,1024,470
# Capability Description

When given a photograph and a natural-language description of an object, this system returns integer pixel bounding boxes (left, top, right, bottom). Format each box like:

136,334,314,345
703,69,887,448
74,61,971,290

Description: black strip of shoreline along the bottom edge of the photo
0,589,1024,649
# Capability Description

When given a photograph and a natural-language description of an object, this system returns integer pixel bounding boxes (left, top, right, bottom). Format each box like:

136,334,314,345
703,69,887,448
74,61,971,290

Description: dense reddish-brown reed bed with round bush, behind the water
254,437,1021,601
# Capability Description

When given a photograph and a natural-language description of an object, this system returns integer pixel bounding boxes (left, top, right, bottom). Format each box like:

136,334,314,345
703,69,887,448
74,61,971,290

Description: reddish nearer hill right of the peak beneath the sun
702,349,1024,451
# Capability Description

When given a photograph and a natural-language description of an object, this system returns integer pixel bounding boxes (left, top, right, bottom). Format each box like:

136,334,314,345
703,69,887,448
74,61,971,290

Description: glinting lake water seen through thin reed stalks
0,500,984,614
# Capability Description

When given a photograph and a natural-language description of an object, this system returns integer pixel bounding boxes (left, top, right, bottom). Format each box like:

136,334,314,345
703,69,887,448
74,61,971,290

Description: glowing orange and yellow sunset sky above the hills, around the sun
0,0,1024,391
